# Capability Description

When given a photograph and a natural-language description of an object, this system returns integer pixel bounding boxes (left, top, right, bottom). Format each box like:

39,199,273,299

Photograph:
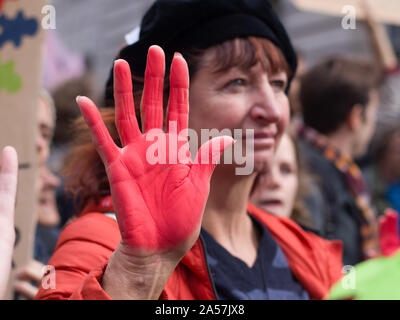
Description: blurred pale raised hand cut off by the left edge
0,147,18,299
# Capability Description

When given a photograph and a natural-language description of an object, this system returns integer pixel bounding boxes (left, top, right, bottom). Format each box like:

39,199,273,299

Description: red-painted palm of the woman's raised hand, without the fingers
107,137,208,249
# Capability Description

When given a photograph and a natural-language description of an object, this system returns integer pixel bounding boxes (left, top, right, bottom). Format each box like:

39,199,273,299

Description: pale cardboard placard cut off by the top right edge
293,0,400,25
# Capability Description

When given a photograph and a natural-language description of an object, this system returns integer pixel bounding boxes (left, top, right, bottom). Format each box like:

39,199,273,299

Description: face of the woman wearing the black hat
189,51,289,172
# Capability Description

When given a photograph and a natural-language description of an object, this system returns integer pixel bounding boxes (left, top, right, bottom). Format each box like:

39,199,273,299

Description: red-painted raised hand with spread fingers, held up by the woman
77,46,233,257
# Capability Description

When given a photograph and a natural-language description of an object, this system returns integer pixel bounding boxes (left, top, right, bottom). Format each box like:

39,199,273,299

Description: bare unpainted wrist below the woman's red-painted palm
102,243,179,300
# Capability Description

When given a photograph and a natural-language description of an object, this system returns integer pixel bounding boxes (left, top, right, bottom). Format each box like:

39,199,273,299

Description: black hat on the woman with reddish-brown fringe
106,0,297,101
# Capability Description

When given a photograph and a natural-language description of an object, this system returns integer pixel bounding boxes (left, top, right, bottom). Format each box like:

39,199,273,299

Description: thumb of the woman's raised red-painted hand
189,136,236,181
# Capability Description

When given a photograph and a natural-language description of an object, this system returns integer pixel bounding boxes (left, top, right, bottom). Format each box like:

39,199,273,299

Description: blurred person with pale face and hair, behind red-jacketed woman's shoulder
250,133,314,230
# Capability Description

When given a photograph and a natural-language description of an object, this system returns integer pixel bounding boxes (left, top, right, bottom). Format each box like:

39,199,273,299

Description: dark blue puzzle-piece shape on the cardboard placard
0,11,38,48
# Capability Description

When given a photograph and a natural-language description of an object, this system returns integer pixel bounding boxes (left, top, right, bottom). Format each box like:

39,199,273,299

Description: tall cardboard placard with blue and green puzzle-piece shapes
0,0,47,299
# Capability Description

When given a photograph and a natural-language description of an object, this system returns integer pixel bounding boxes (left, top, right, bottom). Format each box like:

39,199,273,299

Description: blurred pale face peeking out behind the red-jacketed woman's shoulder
250,135,298,218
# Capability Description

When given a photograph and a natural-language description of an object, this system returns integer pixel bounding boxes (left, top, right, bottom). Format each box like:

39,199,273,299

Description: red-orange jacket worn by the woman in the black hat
36,198,342,300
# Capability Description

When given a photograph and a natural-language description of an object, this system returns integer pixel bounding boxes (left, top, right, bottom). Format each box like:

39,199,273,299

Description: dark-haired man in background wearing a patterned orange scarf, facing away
298,57,381,265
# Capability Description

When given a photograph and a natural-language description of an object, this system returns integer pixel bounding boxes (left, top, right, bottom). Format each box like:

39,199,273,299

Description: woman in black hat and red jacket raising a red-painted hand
37,0,341,299
